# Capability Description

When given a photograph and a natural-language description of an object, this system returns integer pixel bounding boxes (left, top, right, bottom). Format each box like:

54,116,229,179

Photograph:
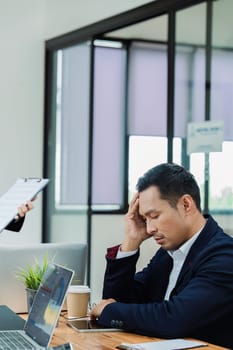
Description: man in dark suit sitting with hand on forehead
90,164,233,348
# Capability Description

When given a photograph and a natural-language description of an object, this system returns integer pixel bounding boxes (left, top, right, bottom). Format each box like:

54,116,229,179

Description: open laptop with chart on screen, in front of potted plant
0,263,74,350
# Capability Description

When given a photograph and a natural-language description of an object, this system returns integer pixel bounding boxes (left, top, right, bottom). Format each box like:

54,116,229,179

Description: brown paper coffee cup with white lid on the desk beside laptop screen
67,285,91,318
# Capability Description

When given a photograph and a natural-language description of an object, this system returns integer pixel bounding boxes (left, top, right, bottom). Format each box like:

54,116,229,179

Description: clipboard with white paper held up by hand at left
0,178,49,232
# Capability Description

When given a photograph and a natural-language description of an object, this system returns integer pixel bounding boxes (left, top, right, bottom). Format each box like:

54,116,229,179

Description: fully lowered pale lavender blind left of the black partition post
56,43,90,205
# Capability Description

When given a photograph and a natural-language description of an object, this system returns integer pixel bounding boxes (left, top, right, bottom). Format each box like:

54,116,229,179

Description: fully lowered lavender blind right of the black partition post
92,47,126,206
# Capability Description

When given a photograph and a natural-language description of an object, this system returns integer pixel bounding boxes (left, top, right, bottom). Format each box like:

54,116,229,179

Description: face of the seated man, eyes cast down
139,186,191,250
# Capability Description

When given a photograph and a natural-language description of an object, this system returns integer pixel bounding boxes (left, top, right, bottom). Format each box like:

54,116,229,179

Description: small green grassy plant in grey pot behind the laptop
16,254,49,312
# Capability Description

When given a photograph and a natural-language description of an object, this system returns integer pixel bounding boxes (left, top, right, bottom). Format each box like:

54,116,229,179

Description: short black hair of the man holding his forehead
136,163,201,211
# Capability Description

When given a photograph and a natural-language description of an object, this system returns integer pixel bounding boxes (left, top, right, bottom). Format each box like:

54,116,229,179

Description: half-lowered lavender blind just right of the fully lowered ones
128,42,167,136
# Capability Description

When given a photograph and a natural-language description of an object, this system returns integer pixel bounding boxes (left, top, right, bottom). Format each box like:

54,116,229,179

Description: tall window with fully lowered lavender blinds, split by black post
55,41,126,210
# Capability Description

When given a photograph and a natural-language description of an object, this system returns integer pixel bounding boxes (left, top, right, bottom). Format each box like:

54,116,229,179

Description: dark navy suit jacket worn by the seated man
99,217,233,349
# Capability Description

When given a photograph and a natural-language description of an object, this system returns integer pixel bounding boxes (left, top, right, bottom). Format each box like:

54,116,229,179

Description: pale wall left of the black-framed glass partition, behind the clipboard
0,0,45,244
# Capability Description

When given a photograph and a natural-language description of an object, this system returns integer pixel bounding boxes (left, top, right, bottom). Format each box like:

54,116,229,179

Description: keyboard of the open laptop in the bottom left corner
0,331,37,350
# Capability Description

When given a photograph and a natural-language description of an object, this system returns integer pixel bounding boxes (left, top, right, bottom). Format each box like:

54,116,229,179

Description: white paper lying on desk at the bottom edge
117,339,207,350
